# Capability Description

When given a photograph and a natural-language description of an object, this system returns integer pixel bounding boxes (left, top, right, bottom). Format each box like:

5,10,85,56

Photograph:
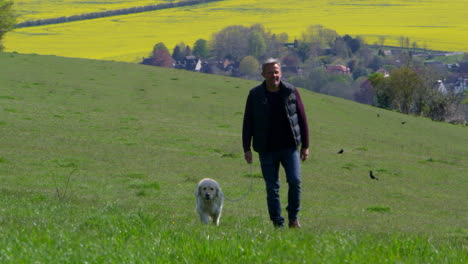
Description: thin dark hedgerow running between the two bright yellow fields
15,0,220,28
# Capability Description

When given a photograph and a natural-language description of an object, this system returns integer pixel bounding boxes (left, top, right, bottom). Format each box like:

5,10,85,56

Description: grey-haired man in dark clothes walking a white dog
242,59,309,228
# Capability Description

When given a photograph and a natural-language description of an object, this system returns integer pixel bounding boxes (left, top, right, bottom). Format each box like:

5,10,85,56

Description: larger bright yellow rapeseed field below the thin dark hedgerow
4,0,468,62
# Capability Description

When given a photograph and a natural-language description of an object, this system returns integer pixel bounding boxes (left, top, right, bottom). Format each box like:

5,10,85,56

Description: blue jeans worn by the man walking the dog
259,148,301,226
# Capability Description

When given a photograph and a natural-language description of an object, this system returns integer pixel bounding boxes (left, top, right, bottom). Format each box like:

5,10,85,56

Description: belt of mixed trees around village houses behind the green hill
146,24,468,121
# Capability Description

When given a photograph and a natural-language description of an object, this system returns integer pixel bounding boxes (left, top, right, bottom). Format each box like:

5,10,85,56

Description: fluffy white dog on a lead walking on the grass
195,178,224,226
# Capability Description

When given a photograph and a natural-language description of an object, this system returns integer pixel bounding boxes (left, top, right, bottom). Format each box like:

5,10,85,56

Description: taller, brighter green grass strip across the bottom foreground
0,200,468,263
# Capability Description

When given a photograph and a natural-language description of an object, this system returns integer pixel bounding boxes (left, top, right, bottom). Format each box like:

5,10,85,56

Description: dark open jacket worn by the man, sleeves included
242,81,309,152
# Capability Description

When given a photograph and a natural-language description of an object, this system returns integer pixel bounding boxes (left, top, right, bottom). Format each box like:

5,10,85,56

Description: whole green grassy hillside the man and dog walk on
0,53,468,263
